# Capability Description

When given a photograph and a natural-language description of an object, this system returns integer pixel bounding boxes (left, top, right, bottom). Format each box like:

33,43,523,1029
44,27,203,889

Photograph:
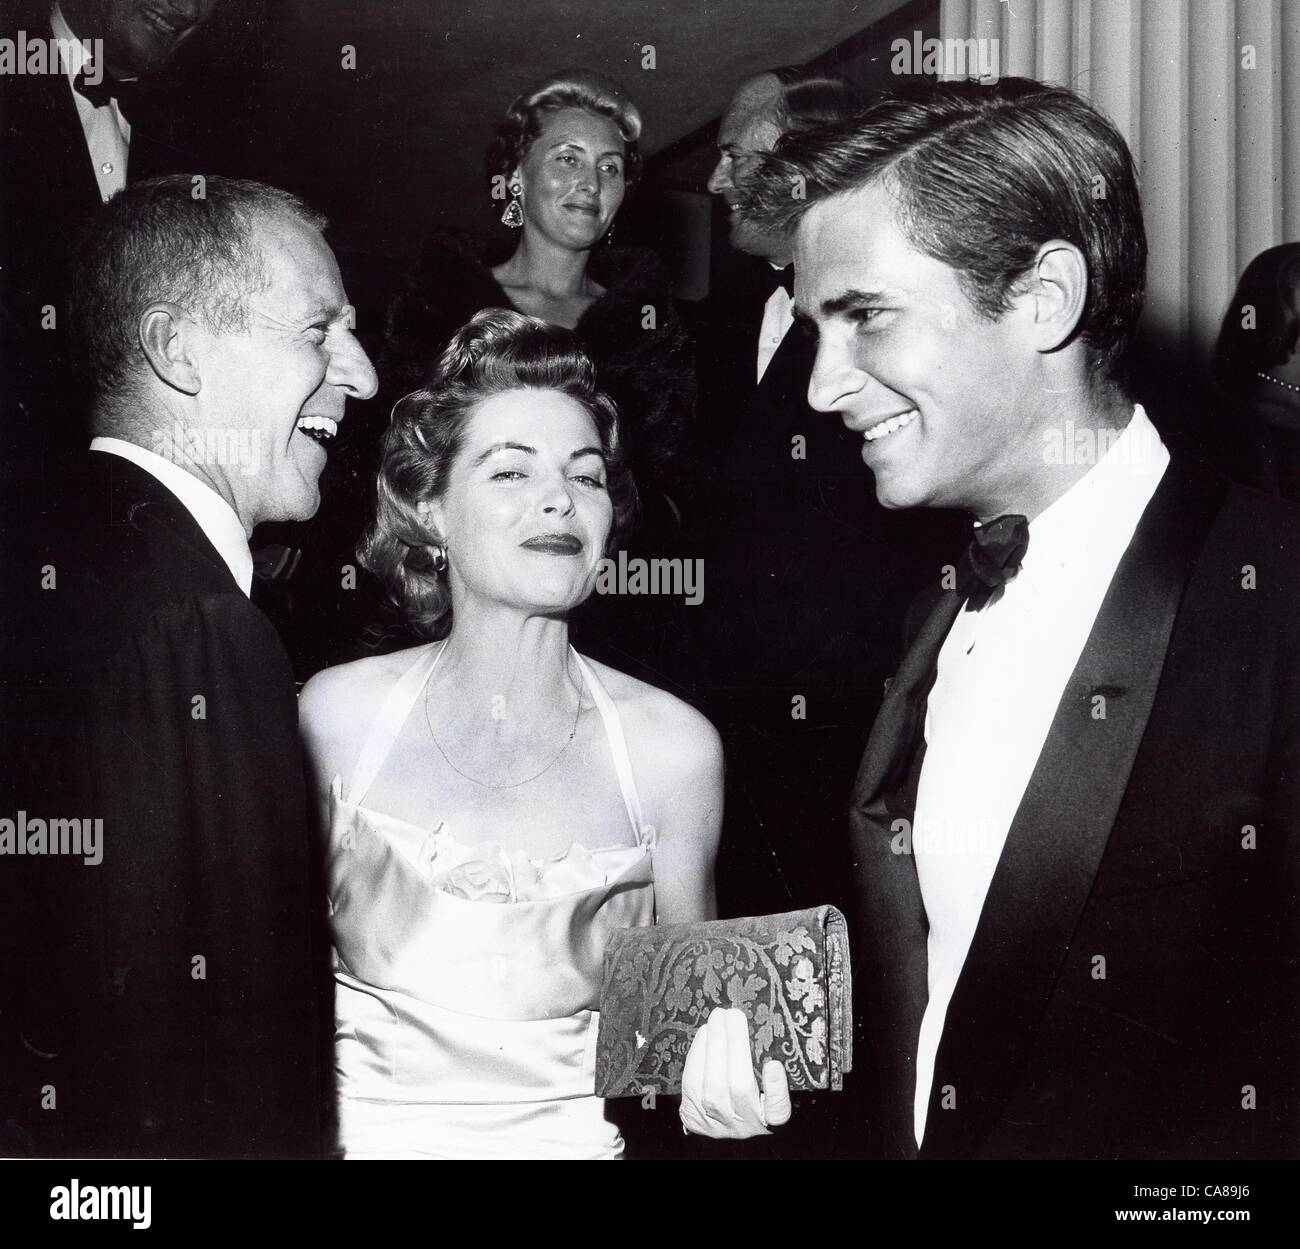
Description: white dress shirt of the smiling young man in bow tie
913,406,1169,1148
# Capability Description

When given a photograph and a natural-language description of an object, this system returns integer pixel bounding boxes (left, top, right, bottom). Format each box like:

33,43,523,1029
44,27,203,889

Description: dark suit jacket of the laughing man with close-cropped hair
0,452,332,1157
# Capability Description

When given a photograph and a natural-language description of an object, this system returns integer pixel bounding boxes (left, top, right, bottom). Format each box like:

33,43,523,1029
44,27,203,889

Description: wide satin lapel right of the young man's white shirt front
922,463,1223,1157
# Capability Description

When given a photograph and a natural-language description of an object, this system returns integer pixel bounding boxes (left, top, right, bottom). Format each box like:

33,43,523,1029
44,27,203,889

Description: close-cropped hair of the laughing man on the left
69,174,326,396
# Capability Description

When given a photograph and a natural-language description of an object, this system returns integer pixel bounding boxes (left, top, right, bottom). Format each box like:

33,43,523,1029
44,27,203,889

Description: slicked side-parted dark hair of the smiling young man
738,78,1147,381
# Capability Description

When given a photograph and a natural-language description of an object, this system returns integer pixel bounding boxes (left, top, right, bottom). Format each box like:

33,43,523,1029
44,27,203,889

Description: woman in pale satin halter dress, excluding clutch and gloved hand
300,311,723,1158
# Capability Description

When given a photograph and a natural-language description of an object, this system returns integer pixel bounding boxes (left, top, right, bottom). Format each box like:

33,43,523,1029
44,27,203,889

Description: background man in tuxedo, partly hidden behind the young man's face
699,68,961,915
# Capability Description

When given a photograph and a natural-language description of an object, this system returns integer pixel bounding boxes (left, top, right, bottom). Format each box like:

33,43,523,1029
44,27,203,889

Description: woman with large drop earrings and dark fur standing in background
380,70,697,691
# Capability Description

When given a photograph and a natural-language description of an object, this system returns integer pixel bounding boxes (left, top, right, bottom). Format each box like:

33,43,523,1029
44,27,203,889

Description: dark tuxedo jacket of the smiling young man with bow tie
850,457,1300,1158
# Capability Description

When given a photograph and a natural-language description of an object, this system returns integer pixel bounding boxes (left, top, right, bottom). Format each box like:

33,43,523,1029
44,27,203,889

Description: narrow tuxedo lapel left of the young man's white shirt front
849,590,963,1157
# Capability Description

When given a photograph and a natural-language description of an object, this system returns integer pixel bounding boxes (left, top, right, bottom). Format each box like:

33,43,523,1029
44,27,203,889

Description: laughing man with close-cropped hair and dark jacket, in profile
0,175,376,1157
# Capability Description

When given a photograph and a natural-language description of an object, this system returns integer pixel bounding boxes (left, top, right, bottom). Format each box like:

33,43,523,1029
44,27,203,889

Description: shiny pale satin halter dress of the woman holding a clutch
328,645,654,1158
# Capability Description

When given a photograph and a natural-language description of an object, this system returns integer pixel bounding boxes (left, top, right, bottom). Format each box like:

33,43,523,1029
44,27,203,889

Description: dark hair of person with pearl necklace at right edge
1214,243,1300,390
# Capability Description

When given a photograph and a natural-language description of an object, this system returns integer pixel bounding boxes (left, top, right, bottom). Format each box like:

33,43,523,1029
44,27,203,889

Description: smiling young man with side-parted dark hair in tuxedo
733,78,1300,1158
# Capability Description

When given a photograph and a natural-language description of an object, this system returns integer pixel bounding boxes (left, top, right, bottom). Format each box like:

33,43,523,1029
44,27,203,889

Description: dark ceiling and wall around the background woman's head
32,0,939,333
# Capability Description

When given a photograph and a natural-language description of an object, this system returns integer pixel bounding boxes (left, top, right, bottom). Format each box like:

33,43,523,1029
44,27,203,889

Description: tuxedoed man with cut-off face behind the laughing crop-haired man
0,0,228,480
